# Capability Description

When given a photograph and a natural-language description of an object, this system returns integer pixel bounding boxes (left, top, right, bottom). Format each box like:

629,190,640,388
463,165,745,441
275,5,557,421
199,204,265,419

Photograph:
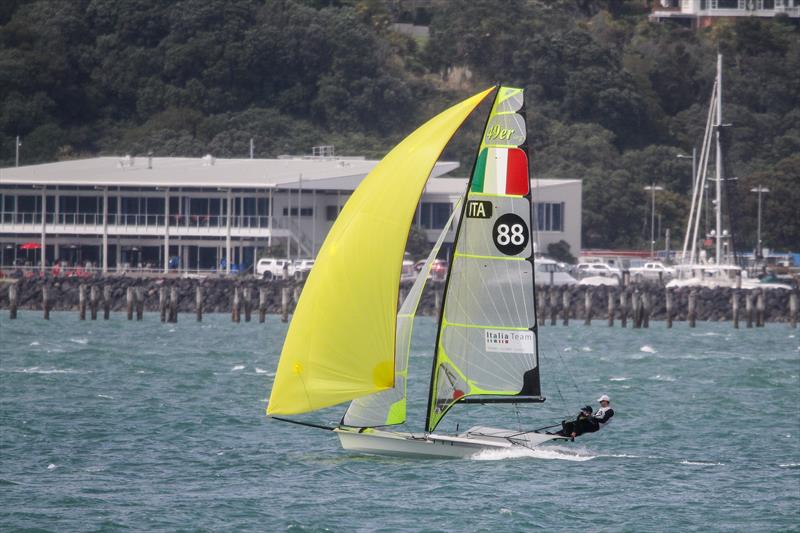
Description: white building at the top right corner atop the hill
650,0,800,28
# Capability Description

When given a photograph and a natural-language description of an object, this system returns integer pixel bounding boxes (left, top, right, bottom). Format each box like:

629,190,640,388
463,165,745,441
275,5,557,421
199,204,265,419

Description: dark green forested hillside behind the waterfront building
0,0,800,250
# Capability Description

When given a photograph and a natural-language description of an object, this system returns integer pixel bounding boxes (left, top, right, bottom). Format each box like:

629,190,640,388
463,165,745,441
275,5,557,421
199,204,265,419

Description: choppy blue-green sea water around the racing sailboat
0,313,800,531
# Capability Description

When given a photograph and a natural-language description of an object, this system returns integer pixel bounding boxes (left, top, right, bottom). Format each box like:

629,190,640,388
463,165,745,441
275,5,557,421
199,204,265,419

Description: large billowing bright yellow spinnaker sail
267,88,494,415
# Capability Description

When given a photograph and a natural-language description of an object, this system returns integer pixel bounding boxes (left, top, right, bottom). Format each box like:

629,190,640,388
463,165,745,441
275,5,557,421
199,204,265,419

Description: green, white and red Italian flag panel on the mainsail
470,147,530,196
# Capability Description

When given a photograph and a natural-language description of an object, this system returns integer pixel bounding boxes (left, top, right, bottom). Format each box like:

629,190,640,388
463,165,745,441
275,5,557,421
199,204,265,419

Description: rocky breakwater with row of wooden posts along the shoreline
0,276,798,329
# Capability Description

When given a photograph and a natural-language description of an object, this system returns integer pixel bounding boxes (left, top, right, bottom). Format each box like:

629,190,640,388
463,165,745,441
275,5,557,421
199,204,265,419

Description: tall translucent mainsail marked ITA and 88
426,87,541,431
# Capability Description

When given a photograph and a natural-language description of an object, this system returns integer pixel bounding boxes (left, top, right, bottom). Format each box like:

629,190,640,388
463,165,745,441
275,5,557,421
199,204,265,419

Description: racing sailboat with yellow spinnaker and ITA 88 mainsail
267,86,563,458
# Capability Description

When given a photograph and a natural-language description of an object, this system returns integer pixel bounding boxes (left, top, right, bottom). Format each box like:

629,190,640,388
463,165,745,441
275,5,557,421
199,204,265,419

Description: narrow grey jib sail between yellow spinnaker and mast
342,201,461,427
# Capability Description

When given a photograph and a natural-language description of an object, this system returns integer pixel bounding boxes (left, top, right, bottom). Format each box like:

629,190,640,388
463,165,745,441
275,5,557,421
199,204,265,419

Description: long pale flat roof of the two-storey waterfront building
0,156,458,190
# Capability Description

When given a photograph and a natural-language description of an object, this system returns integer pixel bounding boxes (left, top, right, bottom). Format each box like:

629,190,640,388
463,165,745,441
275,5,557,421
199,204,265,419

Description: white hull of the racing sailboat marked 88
334,427,564,459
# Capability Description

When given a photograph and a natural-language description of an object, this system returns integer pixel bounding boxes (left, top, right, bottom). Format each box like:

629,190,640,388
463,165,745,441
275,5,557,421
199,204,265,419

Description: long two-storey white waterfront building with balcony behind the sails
0,156,581,272
